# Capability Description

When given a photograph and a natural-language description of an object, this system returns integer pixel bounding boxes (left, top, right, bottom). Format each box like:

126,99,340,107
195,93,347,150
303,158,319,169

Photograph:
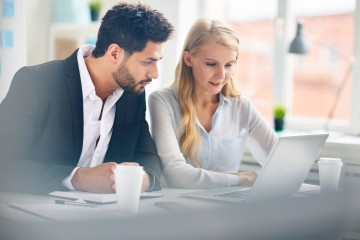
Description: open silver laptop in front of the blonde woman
181,133,329,203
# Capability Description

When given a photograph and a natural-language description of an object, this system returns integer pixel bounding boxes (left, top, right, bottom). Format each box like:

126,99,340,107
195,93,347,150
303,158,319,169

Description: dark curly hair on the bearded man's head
92,3,174,58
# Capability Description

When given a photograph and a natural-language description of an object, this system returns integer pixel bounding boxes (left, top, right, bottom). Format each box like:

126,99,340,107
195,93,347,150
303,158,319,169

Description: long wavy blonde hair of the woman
173,18,240,167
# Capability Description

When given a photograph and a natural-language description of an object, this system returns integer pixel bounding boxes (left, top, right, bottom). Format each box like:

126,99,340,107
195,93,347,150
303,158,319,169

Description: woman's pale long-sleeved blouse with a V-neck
149,88,277,188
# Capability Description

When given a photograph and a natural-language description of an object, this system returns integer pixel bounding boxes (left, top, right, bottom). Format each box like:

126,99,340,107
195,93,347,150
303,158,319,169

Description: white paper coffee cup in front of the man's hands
115,164,145,213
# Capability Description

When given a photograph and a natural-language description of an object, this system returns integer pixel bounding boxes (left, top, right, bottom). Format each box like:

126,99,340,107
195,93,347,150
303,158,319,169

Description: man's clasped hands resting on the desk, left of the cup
71,162,116,193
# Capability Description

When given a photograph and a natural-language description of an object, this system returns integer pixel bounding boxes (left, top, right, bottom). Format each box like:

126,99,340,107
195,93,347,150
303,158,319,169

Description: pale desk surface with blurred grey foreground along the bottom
0,188,360,240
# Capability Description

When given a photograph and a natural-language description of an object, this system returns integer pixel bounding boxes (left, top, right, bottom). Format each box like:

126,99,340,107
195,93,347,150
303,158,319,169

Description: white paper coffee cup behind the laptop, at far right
318,158,343,192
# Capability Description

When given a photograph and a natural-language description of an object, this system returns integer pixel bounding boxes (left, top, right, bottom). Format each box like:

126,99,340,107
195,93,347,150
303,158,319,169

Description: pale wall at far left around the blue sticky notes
0,0,52,101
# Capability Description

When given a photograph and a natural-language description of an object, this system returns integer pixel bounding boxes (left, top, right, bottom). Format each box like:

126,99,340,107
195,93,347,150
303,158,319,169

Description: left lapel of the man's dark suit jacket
64,50,84,159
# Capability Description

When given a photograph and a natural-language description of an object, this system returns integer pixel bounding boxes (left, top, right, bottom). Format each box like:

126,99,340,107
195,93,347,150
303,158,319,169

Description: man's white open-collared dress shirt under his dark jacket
63,45,124,190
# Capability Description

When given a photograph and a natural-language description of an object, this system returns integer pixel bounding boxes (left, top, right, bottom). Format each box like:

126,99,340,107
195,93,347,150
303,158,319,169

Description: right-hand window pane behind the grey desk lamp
289,0,355,133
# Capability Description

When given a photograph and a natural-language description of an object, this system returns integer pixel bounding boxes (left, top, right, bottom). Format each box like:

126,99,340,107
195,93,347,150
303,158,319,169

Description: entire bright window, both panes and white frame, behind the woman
208,0,360,134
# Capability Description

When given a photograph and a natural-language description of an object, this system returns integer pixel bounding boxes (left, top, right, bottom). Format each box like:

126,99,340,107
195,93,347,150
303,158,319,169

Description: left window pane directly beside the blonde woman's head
226,0,277,121
